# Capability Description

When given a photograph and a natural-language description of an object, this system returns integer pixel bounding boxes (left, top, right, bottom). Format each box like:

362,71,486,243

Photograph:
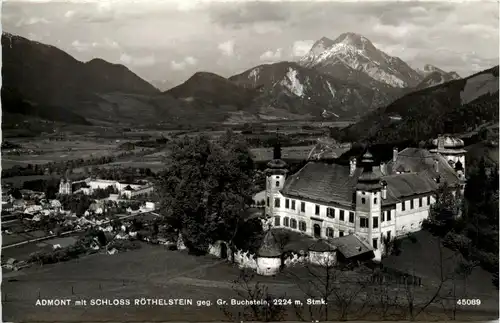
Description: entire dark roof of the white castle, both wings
281,148,460,208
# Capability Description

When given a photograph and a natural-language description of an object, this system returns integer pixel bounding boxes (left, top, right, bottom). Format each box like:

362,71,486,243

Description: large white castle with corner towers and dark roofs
265,136,466,258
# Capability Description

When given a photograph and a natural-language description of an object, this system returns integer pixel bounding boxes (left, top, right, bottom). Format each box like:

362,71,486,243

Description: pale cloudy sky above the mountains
2,0,499,86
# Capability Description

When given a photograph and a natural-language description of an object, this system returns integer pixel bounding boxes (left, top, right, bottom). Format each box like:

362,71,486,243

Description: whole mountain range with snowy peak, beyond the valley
2,33,496,134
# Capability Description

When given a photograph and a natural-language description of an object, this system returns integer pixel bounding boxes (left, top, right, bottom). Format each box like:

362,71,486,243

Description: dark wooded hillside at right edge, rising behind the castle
342,66,498,143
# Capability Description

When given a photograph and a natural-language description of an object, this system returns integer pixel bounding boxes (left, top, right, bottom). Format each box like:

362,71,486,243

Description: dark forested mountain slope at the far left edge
2,33,159,122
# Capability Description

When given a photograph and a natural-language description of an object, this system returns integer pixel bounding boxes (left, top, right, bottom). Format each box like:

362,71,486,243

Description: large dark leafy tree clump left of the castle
158,131,254,251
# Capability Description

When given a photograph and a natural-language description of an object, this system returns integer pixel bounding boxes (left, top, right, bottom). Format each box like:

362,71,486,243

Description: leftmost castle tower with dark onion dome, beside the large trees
264,144,288,229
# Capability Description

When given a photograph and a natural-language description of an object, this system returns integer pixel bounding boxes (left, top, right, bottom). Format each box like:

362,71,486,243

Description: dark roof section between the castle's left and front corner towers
281,162,363,207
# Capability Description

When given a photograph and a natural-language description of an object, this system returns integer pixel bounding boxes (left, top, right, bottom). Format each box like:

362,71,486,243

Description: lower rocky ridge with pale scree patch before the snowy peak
229,62,396,118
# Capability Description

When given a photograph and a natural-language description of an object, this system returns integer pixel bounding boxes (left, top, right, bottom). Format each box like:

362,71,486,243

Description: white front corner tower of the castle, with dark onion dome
355,151,382,254
